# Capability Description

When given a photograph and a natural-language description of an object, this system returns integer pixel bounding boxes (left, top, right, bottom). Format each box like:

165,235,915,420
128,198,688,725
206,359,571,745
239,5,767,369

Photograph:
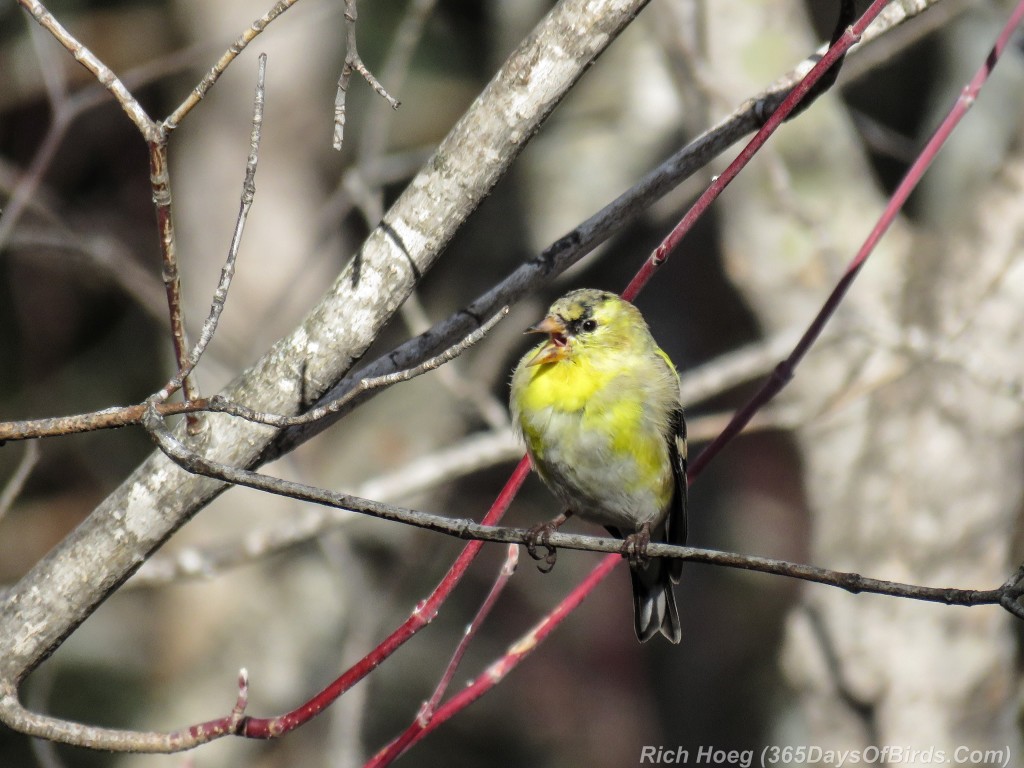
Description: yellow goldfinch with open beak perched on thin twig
510,289,686,643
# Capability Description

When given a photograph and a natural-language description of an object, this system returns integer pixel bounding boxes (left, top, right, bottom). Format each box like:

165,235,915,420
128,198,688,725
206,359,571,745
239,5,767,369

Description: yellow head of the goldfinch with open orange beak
526,288,647,367
